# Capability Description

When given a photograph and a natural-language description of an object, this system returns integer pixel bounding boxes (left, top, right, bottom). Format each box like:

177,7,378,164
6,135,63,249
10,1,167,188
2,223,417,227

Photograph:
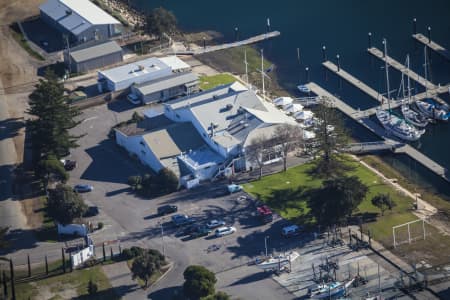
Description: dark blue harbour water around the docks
132,0,450,195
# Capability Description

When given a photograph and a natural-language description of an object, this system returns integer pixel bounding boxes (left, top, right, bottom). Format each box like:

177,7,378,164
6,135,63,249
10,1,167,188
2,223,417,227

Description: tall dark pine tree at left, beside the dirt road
27,71,80,162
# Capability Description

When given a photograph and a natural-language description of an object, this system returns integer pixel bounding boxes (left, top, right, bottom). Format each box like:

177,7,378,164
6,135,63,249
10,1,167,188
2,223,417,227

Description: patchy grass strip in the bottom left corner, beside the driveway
16,266,119,300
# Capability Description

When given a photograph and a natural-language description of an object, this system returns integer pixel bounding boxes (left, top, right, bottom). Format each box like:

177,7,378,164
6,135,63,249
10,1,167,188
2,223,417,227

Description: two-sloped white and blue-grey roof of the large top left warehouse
40,0,120,35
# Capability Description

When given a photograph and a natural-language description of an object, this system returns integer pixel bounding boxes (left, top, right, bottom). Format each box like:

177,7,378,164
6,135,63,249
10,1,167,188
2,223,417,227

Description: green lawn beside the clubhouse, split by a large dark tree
244,158,417,242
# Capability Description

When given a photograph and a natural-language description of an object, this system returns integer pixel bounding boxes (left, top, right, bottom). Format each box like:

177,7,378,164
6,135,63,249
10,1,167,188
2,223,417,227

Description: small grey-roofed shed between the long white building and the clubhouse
131,72,199,104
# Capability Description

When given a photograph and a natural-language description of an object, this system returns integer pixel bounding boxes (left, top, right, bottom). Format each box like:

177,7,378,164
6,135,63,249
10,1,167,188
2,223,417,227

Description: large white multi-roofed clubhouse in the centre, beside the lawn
116,82,300,180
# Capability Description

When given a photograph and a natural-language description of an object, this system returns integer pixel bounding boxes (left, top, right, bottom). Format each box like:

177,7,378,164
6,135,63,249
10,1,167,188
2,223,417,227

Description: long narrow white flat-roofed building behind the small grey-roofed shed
98,56,190,92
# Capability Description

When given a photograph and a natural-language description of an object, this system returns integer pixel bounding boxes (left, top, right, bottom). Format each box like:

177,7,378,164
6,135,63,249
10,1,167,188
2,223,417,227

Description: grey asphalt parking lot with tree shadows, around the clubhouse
69,101,298,299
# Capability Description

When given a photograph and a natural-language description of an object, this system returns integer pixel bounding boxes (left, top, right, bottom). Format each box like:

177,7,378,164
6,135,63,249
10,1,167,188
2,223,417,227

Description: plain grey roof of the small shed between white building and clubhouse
136,72,198,95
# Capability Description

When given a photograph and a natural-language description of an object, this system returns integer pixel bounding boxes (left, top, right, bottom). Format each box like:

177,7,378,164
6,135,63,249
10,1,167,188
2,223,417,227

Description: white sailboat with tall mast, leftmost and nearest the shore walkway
376,39,425,141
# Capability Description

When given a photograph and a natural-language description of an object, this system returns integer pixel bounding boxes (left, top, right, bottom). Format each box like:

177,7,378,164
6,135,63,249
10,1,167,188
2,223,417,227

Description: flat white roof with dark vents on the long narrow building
99,57,170,82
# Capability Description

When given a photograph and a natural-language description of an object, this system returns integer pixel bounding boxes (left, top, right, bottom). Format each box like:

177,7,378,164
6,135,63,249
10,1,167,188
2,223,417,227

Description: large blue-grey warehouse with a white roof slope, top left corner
39,0,120,43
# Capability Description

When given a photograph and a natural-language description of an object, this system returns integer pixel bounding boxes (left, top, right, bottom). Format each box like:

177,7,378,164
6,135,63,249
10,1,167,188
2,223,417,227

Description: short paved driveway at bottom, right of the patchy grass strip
102,261,147,300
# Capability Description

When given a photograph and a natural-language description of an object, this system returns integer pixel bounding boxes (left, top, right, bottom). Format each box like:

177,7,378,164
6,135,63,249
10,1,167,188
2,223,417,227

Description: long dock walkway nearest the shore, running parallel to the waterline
306,81,450,182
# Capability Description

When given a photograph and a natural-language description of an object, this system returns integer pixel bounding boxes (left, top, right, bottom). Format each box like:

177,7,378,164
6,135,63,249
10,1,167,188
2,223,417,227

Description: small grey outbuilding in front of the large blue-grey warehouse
64,41,123,73
